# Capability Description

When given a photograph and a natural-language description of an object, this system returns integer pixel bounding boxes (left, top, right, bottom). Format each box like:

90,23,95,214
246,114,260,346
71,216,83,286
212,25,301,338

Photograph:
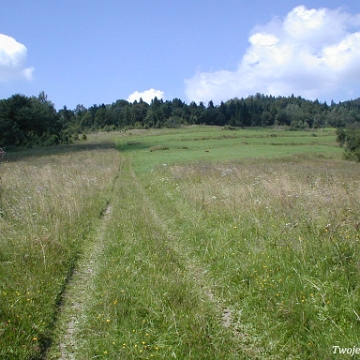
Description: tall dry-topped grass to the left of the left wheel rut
0,147,119,359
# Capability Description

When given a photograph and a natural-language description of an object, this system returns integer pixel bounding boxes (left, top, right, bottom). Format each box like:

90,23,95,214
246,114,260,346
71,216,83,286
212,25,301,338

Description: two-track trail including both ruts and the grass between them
48,156,240,359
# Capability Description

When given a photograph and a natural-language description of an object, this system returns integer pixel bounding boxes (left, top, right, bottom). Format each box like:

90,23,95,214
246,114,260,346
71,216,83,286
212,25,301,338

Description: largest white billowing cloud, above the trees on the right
185,6,360,102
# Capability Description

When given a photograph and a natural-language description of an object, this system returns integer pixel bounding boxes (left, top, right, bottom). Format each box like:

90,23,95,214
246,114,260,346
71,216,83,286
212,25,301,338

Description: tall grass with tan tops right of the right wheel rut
147,157,360,359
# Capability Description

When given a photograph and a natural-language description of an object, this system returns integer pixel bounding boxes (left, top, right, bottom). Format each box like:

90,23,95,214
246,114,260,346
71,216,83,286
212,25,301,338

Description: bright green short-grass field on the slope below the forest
115,126,342,171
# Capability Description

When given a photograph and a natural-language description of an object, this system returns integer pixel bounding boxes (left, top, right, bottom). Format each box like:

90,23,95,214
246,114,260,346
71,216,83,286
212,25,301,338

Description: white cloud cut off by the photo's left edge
0,34,34,81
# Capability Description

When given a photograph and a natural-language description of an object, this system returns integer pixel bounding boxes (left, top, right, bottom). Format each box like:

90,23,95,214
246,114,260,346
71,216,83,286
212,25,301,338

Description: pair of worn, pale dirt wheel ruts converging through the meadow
48,158,236,360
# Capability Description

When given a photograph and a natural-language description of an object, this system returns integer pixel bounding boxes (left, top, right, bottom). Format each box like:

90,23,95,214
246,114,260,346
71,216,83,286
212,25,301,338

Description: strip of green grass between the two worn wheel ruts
51,160,237,359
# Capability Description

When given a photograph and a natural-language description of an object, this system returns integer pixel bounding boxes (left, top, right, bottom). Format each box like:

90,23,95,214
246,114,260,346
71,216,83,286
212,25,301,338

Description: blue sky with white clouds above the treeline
0,0,360,109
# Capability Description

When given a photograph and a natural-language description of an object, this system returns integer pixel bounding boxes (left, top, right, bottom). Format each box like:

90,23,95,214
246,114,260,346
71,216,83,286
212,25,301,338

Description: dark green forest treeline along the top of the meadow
0,92,360,147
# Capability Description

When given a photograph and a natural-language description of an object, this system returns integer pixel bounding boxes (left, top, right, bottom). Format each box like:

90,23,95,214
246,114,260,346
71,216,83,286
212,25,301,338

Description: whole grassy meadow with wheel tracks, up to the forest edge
0,126,360,359
